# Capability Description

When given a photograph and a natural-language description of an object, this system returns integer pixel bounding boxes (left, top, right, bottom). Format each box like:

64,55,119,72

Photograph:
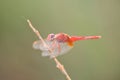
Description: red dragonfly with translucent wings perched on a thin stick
33,33,101,58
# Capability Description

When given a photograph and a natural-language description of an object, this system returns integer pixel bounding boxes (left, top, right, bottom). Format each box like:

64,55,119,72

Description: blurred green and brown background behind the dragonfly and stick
0,0,120,80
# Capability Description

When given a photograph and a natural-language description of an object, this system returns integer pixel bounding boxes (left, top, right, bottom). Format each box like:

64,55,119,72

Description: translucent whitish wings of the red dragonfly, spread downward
33,40,72,58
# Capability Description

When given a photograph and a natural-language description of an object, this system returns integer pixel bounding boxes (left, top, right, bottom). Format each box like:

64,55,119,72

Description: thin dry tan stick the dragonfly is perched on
27,19,71,80
